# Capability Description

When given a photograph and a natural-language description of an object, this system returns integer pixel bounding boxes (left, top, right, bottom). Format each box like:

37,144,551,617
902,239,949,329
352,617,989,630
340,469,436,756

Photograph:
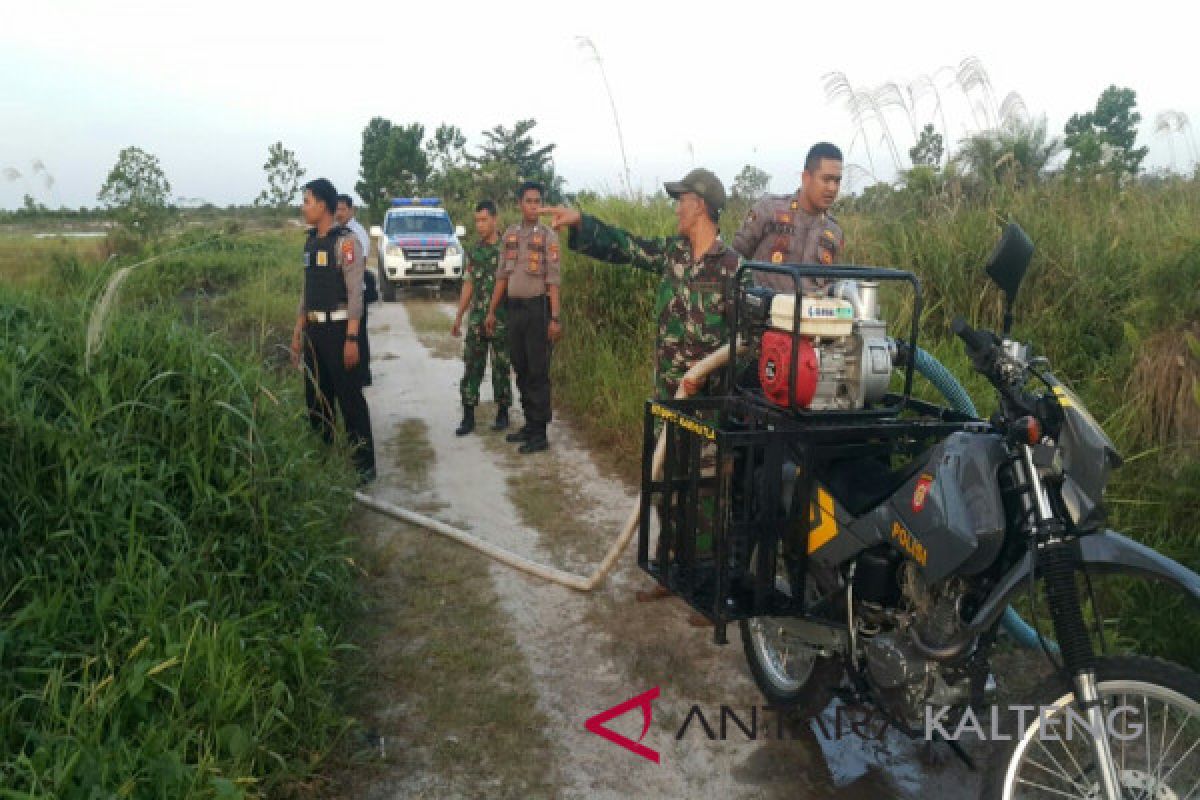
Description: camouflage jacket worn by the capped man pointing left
568,215,740,399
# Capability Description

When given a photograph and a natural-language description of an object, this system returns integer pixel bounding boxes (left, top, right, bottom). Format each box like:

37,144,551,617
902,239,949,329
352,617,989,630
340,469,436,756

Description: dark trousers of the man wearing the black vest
304,321,374,473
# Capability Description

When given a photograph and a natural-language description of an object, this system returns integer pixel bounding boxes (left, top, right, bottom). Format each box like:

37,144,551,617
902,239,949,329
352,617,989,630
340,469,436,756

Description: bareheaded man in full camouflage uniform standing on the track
450,200,512,437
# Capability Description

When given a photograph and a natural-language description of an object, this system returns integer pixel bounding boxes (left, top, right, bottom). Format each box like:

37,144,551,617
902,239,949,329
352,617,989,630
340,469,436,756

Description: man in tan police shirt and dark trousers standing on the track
484,181,563,453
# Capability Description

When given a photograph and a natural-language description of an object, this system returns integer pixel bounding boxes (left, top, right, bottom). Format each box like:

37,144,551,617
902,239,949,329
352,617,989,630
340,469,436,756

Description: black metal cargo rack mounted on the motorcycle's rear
637,263,986,644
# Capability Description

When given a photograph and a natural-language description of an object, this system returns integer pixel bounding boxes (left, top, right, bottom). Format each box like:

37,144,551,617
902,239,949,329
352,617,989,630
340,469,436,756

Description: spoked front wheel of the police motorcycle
983,656,1200,800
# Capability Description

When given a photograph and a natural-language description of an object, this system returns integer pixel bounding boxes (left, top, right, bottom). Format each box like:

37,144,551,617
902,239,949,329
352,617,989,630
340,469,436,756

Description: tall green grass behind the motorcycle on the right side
553,180,1200,664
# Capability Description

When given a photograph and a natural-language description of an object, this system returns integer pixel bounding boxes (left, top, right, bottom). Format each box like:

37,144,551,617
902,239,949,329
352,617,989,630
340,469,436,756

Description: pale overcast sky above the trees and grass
0,0,1200,207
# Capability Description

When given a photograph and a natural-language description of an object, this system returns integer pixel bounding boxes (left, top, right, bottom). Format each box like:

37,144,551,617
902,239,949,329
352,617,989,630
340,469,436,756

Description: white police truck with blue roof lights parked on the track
371,197,467,301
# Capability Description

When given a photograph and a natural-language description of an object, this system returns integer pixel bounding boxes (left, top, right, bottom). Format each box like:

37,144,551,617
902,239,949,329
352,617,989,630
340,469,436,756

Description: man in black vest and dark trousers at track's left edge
292,178,376,483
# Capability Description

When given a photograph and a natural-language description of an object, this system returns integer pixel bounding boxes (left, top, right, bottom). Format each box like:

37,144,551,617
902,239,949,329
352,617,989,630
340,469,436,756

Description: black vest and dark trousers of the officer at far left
304,225,376,477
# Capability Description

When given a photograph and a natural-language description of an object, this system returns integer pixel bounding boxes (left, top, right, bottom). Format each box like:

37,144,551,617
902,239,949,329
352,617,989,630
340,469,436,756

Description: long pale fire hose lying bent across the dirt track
354,347,730,591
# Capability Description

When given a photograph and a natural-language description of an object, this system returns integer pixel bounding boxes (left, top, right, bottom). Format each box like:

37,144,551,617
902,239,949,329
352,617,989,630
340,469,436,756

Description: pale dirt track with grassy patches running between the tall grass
343,297,974,800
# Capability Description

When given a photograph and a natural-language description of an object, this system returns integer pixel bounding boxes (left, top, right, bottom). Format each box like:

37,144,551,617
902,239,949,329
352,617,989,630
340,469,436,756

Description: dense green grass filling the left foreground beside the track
0,235,356,799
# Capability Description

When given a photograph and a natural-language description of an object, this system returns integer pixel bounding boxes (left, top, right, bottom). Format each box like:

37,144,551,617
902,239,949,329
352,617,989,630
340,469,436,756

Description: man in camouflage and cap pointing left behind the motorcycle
544,169,742,606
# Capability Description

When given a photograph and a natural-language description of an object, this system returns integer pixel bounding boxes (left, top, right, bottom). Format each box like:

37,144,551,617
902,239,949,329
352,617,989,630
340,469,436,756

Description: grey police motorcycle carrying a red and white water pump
637,224,1200,800
